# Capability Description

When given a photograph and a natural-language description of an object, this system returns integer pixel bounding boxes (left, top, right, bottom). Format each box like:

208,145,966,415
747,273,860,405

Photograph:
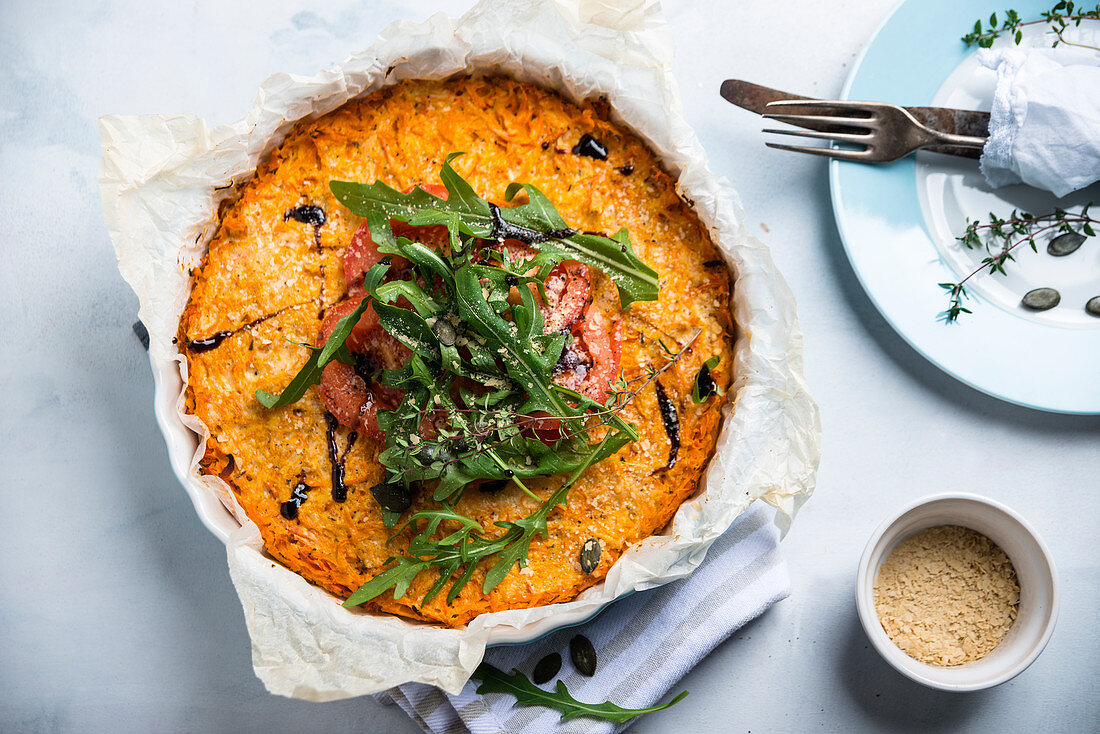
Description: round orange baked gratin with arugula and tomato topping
178,76,733,626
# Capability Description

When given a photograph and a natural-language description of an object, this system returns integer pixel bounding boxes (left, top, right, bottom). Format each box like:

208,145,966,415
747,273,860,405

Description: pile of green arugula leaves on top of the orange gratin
256,158,658,606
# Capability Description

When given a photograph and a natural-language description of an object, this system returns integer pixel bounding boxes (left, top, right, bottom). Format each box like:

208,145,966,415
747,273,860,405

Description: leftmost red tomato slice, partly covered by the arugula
317,297,413,437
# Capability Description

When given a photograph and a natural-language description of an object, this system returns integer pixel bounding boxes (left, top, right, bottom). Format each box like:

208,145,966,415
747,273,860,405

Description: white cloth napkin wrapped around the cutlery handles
978,26,1100,197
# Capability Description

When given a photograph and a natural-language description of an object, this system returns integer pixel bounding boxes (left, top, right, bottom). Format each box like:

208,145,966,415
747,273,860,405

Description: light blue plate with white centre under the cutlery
829,0,1100,414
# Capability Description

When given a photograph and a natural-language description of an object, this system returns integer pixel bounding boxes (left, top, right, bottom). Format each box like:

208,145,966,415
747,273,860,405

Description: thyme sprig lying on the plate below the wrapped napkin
939,204,1100,324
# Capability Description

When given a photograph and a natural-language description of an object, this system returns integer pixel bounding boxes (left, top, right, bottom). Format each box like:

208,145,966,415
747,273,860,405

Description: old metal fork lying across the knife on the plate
763,99,986,163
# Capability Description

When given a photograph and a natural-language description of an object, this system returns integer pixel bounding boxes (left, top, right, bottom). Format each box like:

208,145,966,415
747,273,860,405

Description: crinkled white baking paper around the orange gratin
100,0,820,701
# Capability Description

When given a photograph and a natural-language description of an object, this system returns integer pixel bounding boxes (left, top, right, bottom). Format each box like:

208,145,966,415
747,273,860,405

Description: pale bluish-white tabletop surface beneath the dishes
0,0,1100,734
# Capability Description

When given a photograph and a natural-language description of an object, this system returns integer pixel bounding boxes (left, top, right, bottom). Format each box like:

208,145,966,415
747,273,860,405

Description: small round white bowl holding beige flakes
856,494,1058,691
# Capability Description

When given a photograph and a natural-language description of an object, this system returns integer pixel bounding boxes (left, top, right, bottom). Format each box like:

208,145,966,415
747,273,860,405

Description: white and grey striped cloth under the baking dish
377,502,790,734
